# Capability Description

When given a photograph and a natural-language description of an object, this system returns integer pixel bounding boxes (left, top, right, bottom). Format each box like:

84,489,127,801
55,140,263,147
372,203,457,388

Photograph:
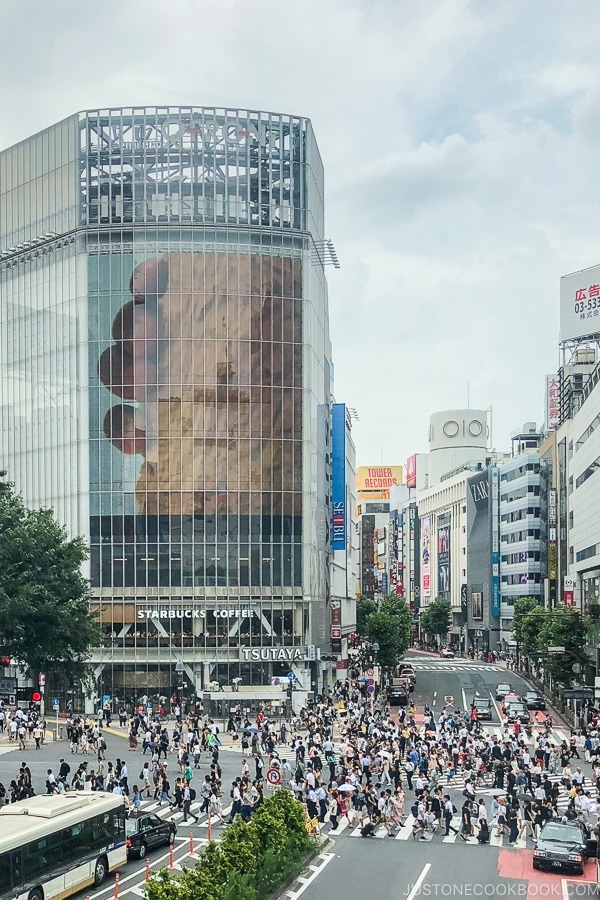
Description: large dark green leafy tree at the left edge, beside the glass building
0,472,100,677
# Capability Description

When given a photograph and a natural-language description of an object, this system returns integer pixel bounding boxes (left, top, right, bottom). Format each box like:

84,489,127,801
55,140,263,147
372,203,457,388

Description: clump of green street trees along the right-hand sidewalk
513,597,591,687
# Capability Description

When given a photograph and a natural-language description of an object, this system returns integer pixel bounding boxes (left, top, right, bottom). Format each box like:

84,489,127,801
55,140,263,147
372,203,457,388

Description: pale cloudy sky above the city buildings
0,0,600,465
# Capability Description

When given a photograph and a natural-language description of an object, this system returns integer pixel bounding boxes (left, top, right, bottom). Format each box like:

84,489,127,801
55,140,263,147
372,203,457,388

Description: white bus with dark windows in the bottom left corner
0,791,127,900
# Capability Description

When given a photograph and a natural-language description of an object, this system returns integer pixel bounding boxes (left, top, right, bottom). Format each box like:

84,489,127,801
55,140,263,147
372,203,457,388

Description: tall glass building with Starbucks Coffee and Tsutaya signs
0,107,332,703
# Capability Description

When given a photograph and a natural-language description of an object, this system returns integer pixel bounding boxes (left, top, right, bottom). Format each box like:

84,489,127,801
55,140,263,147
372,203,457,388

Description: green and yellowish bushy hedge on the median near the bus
145,790,313,900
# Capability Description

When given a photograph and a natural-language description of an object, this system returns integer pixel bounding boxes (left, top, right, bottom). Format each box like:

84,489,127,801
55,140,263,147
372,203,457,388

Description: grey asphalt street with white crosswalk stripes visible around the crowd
0,652,596,900
